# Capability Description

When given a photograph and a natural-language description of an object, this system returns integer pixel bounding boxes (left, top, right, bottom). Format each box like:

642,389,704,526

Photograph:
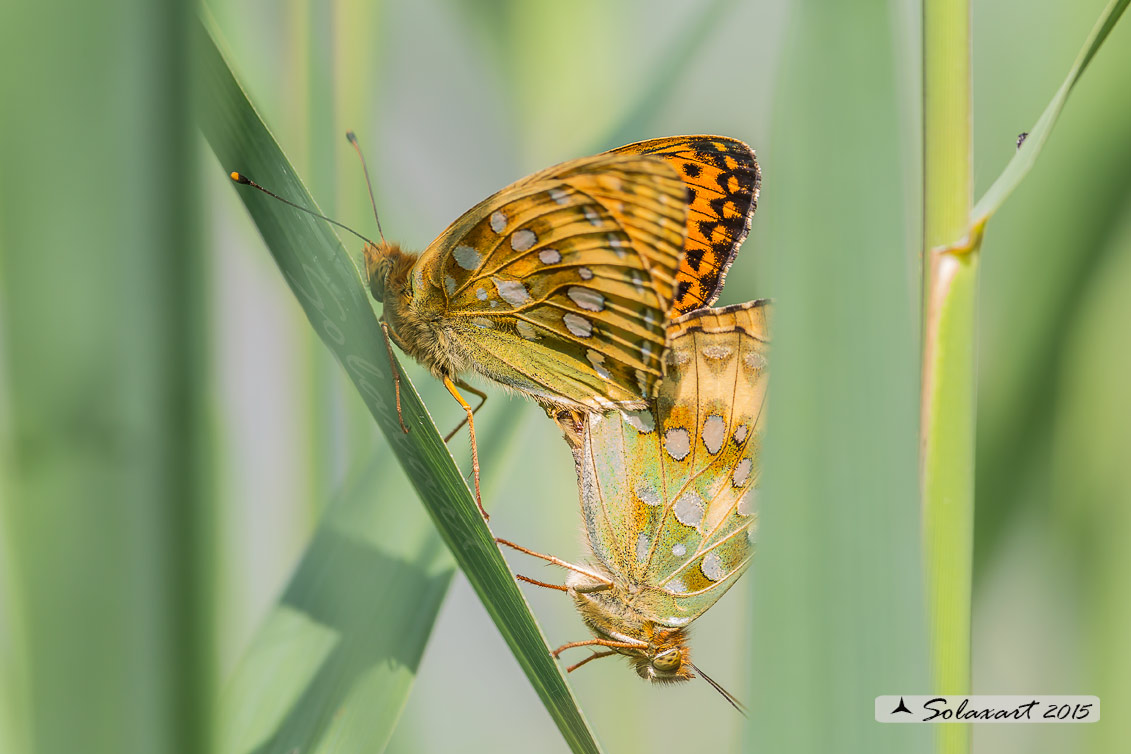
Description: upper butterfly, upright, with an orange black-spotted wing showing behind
364,136,760,518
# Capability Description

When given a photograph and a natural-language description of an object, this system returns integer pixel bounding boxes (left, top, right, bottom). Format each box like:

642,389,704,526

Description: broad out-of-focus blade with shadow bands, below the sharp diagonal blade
218,462,454,754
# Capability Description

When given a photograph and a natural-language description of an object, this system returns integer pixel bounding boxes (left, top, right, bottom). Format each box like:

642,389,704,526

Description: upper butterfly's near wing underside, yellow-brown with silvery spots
413,154,688,409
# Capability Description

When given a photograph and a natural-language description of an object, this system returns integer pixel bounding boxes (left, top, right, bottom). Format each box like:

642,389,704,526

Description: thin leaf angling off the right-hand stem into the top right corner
970,0,1131,227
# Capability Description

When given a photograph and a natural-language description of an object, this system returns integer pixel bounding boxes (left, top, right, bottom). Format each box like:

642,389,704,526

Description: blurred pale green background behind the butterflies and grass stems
0,0,1131,754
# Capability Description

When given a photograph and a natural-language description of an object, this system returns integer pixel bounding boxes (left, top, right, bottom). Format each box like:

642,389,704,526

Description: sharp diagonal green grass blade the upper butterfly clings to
199,16,599,752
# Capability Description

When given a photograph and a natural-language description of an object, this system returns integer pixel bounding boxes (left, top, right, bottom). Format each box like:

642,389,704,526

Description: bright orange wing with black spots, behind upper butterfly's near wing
613,136,761,314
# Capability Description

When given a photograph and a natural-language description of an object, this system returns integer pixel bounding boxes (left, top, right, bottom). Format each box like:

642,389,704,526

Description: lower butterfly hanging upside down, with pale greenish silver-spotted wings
498,301,769,709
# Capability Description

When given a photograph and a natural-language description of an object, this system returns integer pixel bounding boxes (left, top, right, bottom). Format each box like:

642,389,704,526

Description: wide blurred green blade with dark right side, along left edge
0,0,215,754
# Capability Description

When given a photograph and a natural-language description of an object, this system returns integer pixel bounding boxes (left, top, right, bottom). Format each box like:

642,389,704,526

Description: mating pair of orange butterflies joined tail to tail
233,136,766,701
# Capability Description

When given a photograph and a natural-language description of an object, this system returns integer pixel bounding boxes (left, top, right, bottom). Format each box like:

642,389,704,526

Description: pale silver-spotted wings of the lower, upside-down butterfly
579,302,769,626
